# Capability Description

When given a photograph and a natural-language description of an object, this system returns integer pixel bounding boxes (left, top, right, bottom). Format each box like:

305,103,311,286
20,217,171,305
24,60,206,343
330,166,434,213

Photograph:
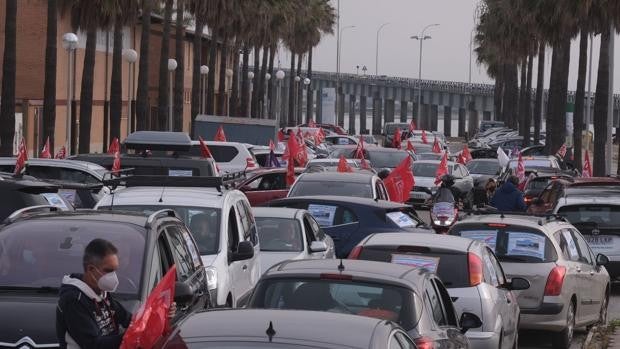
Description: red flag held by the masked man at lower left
120,266,177,349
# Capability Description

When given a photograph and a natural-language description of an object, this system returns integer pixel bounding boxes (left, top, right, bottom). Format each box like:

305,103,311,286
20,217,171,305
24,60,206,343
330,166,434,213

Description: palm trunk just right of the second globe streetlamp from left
136,0,153,131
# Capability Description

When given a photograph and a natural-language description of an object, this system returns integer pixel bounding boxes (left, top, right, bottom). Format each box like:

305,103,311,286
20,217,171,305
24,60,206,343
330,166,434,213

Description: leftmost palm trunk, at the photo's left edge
0,0,16,156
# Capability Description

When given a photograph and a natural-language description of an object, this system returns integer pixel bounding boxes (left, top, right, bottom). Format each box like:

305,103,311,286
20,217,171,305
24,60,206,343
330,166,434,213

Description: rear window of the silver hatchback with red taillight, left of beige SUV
359,246,469,288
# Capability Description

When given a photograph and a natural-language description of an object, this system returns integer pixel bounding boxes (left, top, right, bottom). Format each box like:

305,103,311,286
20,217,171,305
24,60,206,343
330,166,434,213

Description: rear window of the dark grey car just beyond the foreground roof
249,278,422,330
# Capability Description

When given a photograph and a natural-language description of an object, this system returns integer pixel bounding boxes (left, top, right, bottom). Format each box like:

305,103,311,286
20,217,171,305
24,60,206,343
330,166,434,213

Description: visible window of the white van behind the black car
99,205,220,255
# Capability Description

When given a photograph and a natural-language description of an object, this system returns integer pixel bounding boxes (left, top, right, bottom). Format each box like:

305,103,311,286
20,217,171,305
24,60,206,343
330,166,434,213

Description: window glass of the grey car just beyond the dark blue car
289,180,372,199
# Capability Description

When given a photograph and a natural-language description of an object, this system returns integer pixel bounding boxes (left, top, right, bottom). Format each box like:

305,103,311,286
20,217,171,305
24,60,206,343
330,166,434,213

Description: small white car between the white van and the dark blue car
253,207,335,272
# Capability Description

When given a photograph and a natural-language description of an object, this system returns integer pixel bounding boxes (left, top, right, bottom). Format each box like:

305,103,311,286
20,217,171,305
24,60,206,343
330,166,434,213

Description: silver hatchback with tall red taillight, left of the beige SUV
352,233,529,349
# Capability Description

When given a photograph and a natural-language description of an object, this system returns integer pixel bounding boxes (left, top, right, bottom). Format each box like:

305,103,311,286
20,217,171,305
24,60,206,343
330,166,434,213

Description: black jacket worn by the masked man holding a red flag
56,274,131,349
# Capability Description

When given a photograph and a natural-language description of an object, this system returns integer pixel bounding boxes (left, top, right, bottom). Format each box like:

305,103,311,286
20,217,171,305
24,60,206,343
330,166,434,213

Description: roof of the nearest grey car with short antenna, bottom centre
158,309,415,349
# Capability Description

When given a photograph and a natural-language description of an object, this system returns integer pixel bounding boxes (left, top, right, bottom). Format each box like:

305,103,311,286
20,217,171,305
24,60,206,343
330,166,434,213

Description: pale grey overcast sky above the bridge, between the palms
281,0,620,91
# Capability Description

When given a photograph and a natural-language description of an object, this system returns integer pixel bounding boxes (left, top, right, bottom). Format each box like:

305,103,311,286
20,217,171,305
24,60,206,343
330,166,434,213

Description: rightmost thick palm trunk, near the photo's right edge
593,30,610,177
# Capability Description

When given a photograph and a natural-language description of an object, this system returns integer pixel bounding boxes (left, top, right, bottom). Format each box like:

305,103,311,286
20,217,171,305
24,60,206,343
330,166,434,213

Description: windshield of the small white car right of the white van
256,217,304,252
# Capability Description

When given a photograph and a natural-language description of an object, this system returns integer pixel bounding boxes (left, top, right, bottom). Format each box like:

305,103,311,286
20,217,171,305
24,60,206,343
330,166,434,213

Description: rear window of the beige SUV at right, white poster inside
450,224,557,263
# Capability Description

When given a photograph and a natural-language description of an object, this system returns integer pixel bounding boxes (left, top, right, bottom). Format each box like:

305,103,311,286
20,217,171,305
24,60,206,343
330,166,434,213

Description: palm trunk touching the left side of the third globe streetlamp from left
157,0,174,131
